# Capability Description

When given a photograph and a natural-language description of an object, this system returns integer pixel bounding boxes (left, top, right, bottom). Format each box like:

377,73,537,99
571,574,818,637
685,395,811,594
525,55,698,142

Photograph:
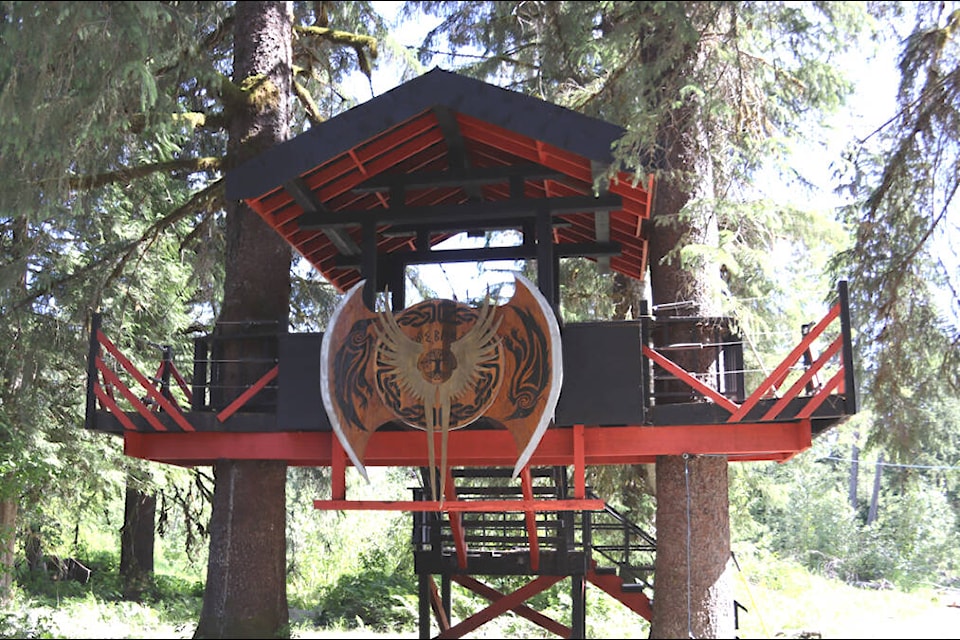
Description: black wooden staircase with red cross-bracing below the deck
413,466,656,638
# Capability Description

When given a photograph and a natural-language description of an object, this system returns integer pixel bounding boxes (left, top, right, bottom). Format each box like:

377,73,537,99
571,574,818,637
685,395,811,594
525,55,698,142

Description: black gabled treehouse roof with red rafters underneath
226,69,651,291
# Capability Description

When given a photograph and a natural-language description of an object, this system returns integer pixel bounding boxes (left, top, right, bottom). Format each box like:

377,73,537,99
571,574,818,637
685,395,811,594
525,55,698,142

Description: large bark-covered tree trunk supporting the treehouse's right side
650,118,735,638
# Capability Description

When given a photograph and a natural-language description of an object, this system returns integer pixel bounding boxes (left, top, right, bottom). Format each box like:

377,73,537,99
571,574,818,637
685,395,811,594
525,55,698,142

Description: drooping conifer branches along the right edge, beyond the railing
833,2,960,461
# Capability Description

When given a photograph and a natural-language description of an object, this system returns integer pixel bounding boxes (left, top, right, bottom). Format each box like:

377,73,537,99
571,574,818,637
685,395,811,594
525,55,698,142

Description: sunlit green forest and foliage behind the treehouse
0,2,960,637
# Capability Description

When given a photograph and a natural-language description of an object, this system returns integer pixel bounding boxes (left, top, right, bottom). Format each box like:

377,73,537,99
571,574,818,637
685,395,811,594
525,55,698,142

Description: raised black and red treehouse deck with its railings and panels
86,283,856,467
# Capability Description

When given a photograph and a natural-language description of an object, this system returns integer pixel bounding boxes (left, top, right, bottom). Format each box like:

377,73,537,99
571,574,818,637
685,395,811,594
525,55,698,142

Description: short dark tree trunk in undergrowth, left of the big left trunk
120,480,157,601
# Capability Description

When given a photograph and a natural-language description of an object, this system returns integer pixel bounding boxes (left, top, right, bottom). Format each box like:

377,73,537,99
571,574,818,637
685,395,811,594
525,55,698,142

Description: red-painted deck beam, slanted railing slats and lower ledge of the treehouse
88,288,849,502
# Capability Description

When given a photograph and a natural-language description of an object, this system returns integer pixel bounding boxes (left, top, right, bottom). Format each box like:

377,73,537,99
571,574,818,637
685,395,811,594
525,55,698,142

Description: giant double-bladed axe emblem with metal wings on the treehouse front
320,275,563,499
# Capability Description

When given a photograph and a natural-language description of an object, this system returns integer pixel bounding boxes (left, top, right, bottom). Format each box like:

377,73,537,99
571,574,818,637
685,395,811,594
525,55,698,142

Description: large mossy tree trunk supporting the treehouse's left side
194,2,293,638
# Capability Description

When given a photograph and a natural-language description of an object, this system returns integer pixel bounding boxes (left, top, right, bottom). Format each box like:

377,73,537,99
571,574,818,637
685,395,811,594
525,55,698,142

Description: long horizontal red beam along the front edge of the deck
118,419,812,468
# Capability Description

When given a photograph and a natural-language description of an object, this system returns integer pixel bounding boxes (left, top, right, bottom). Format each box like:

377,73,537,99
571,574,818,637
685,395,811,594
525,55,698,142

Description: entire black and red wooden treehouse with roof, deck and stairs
86,69,857,638
